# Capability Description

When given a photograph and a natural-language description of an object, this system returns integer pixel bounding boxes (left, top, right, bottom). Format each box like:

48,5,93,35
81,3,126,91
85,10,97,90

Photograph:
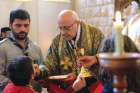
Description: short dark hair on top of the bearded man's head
10,9,30,23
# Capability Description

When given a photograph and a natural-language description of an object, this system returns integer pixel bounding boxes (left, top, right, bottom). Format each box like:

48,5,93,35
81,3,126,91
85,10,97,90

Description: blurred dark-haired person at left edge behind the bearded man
0,27,11,40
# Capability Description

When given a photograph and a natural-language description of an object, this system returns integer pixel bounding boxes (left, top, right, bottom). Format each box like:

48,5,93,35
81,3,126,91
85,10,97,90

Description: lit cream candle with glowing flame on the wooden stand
113,11,124,55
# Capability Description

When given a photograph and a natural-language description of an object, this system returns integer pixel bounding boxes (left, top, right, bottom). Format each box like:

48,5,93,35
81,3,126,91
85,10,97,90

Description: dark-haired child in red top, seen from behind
3,56,35,93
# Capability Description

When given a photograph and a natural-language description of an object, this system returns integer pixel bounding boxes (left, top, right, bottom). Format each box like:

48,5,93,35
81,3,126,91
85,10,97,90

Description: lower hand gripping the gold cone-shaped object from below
72,75,86,91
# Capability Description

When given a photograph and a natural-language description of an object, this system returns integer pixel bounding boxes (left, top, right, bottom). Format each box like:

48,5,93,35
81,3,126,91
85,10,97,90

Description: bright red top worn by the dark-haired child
3,83,35,93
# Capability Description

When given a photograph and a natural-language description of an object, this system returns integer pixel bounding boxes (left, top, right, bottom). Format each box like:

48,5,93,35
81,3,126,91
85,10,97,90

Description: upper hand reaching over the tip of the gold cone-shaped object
77,56,98,68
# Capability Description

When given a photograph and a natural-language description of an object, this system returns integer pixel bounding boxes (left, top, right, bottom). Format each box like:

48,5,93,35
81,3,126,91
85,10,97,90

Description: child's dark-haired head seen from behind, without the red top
7,56,34,86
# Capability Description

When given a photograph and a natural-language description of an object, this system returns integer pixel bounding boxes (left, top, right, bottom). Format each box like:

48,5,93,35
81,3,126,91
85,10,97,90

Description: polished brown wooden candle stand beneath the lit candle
98,53,140,93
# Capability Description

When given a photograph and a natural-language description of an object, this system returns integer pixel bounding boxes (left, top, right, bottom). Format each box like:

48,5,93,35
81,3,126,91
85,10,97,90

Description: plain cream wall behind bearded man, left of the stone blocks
0,0,71,55
